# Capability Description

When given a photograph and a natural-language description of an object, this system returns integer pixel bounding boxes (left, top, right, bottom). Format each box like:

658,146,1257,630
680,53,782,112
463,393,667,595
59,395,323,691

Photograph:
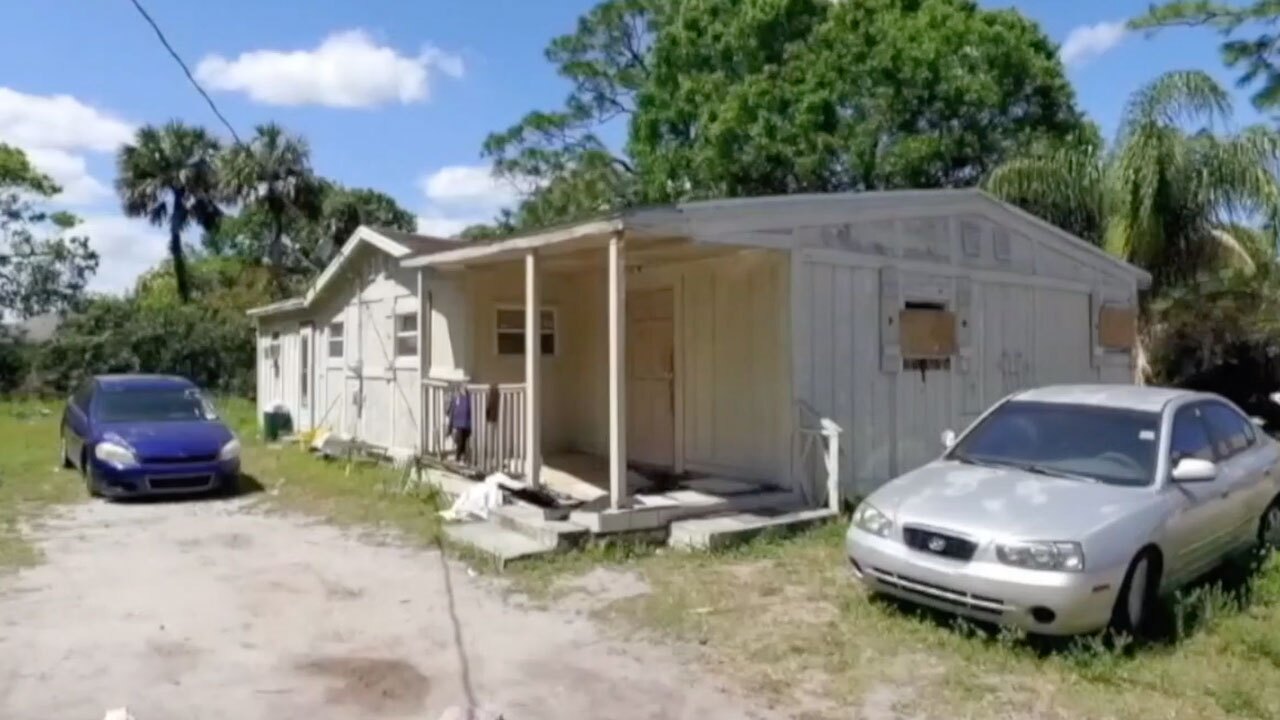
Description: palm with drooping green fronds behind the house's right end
986,72,1280,291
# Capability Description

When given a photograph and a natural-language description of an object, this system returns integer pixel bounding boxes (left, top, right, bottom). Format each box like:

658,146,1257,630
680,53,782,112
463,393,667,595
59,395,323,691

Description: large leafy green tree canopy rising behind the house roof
481,0,1097,236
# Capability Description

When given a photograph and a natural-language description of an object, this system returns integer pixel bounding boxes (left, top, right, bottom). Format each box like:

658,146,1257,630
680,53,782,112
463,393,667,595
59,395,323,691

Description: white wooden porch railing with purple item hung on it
422,378,527,475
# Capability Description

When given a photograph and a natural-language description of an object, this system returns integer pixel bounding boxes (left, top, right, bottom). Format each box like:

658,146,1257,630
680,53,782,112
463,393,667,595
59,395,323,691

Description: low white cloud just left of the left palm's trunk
70,215,169,295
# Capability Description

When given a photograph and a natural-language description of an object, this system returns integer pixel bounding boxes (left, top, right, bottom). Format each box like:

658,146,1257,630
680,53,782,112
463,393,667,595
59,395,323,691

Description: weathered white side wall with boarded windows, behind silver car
792,213,1137,496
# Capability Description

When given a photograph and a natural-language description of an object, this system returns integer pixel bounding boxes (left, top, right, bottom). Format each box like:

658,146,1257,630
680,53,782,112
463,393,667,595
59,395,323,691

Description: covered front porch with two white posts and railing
408,221,838,533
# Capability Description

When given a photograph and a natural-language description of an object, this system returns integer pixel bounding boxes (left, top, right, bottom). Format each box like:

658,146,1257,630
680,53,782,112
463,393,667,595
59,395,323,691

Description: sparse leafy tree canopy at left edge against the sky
0,143,97,320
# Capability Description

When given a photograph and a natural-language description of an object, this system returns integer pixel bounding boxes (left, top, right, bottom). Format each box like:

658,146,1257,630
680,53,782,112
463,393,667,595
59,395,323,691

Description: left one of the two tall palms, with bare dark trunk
115,120,221,300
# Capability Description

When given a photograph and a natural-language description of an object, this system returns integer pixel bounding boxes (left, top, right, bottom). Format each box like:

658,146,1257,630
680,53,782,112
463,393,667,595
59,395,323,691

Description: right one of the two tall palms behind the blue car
220,123,321,282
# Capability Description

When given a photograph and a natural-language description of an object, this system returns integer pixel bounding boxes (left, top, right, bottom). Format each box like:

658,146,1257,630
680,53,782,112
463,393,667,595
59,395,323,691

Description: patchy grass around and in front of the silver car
499,524,1280,720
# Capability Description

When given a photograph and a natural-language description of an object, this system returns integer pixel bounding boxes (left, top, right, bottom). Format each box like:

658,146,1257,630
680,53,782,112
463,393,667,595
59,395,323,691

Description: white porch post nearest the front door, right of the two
608,232,627,510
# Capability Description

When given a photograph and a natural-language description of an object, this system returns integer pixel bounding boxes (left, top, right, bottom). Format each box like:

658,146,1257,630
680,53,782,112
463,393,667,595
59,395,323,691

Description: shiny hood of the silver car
867,460,1156,541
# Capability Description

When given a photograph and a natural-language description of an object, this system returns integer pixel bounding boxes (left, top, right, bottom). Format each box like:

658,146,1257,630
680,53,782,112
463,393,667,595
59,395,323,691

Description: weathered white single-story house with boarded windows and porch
251,190,1149,530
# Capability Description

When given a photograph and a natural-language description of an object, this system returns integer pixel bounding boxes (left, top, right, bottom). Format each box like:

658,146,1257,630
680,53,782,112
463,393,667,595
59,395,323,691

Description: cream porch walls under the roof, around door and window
450,251,791,484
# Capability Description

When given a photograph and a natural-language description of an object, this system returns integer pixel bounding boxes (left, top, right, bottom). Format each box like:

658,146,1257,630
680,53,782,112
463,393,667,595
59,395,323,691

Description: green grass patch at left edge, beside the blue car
0,401,86,573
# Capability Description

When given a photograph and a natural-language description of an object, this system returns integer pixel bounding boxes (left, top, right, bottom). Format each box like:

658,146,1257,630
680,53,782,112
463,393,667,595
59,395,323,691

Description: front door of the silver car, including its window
1165,405,1235,582
